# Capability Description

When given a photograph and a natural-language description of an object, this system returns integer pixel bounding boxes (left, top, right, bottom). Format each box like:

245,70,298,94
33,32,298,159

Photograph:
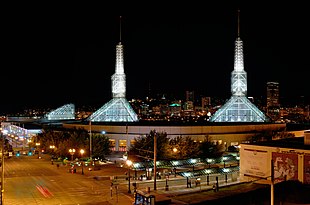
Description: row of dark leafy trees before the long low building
29,128,225,160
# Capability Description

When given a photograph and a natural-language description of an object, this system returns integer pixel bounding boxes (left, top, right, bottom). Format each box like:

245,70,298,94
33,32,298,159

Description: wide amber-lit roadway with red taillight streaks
4,156,132,205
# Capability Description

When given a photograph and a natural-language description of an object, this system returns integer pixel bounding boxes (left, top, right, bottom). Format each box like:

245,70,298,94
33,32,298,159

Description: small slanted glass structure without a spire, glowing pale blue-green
45,104,75,120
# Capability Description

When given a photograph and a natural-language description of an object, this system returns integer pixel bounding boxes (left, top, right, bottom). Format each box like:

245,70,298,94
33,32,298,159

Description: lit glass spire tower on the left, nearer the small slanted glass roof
89,18,138,122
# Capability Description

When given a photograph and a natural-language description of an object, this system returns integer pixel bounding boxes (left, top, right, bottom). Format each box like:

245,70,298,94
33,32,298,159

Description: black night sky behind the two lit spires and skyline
0,5,310,113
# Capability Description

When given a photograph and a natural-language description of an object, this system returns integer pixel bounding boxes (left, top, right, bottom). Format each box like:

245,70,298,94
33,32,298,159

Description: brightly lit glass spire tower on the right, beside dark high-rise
210,11,269,122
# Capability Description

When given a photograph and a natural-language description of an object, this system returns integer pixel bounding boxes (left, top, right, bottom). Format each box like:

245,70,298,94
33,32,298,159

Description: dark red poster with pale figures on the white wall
272,152,298,183
